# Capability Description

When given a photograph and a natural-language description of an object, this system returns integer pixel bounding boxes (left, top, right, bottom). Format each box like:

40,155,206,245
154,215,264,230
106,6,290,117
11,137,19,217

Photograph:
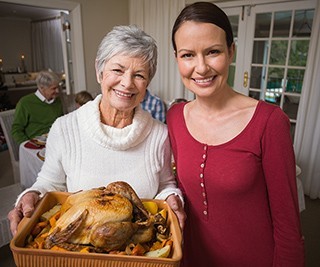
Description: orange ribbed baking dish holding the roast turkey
10,192,182,267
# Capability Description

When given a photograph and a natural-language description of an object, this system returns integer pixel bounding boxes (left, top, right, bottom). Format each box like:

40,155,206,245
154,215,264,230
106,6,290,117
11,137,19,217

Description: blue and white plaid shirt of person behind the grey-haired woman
141,90,166,122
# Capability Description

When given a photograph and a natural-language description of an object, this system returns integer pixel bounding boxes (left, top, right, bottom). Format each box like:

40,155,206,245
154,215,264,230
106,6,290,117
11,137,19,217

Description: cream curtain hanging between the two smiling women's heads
129,0,187,103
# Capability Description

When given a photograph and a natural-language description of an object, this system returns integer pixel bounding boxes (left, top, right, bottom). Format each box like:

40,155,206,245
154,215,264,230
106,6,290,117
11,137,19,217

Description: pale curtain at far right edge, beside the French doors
295,1,320,199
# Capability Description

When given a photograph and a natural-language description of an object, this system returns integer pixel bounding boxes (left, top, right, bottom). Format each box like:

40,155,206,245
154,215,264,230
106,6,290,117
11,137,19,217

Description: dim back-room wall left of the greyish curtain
0,18,31,74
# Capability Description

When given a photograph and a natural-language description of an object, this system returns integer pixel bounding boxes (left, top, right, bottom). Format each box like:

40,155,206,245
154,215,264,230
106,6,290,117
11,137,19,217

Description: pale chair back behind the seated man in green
0,109,20,182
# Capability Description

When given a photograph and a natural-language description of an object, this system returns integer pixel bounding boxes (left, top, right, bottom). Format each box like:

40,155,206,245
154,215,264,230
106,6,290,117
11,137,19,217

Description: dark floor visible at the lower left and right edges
0,151,320,267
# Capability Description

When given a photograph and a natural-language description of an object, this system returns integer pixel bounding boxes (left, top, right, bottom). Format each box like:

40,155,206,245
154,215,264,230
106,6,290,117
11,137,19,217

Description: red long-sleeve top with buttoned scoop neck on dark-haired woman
167,101,304,267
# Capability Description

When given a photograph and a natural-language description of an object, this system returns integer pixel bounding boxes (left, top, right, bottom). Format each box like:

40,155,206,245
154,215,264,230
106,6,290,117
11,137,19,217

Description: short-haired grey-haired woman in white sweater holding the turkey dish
8,26,185,234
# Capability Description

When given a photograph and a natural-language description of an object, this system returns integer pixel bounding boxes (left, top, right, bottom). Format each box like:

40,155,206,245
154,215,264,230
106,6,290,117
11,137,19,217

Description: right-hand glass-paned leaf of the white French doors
247,2,314,140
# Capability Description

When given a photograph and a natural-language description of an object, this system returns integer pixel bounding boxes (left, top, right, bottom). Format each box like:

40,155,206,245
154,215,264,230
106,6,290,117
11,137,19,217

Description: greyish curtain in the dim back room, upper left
31,19,64,73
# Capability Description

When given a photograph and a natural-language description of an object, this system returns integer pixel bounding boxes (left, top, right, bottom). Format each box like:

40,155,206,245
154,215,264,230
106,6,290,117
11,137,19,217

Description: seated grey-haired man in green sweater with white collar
11,71,63,144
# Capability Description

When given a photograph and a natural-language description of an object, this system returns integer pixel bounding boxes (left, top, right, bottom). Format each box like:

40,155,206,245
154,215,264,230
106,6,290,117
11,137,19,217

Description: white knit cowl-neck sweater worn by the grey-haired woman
17,95,182,202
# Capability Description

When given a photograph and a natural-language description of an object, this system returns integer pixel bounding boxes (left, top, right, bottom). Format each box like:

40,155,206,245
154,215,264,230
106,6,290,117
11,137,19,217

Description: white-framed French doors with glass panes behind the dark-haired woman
221,0,316,141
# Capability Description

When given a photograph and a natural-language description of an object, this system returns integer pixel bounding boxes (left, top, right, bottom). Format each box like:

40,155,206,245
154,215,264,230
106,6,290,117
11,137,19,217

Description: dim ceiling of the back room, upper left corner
0,2,61,20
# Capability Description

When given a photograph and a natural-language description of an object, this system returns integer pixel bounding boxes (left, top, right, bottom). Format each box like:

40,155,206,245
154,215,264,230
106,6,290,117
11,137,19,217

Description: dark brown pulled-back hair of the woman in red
171,2,233,52
